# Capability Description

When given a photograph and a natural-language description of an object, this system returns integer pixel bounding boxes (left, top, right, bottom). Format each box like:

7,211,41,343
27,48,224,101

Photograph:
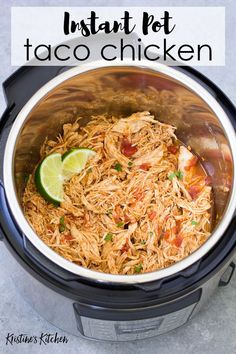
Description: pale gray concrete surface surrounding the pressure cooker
0,0,236,354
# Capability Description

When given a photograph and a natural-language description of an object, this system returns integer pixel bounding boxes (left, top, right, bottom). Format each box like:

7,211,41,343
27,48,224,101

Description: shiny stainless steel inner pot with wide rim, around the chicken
4,60,236,283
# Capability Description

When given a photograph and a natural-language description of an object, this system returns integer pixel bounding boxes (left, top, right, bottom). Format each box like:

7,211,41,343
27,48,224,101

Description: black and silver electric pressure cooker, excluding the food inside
0,60,236,341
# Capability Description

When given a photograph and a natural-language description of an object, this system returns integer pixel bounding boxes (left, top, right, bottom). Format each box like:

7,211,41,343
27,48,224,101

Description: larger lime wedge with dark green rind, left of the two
35,153,64,205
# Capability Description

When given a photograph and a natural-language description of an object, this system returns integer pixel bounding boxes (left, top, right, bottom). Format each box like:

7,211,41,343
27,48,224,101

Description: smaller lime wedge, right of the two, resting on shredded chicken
62,147,96,180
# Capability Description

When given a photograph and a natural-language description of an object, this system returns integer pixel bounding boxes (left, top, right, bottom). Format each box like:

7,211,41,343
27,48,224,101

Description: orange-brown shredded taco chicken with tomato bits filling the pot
23,112,213,274
